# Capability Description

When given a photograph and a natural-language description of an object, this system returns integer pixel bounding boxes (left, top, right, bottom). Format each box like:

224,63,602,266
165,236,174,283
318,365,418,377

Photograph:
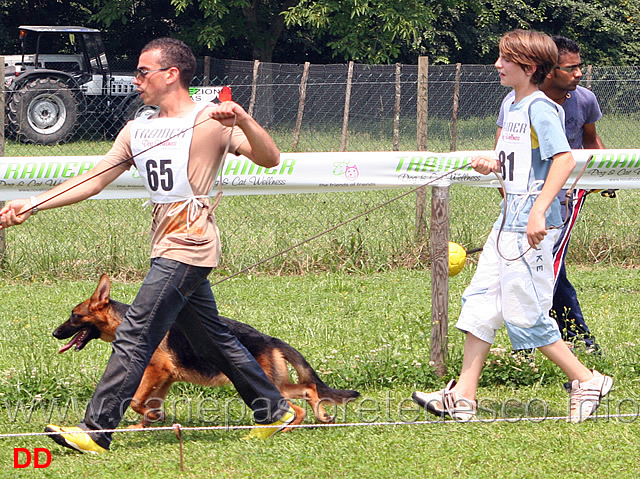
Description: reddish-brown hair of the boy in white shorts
500,30,558,85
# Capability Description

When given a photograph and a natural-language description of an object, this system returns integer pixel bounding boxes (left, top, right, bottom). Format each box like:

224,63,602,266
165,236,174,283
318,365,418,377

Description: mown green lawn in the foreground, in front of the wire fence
0,266,640,478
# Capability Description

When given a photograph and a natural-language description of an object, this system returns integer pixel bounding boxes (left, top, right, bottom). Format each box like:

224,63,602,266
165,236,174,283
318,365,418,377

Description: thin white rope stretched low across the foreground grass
0,413,640,439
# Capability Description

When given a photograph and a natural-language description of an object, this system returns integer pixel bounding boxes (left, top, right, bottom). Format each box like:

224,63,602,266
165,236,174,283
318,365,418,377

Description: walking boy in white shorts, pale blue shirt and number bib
413,30,613,422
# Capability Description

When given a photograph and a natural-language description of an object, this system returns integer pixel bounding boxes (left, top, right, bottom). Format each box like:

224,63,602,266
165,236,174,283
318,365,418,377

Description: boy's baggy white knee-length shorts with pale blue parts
456,230,561,349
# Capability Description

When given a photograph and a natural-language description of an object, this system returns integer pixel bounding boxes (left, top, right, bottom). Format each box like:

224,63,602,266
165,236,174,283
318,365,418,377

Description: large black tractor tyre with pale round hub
8,78,78,145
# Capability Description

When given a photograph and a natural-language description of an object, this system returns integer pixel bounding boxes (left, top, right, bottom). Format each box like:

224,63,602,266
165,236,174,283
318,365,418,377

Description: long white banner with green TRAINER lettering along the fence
0,149,640,201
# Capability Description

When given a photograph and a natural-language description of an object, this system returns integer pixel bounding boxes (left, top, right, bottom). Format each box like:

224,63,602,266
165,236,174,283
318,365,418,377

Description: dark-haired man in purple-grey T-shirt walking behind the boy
496,36,604,352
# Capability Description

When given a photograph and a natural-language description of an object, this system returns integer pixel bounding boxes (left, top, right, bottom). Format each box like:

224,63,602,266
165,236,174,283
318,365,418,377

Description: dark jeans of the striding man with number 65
80,258,289,448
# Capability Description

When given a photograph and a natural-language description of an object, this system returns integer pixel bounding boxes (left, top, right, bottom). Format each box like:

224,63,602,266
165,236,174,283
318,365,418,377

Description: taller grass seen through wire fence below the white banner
0,176,640,281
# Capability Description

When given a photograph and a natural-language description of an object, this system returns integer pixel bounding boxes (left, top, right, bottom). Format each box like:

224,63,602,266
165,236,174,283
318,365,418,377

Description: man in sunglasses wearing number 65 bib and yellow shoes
0,38,295,454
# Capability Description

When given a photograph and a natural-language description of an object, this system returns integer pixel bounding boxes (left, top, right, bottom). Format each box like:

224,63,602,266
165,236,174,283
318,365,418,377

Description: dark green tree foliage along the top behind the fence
0,0,640,65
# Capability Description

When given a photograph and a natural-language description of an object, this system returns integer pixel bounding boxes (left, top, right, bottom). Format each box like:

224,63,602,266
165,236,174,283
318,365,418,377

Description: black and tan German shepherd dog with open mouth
53,274,360,428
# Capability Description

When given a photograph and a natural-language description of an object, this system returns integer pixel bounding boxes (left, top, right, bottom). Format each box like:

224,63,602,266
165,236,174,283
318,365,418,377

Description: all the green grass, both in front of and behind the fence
0,114,640,479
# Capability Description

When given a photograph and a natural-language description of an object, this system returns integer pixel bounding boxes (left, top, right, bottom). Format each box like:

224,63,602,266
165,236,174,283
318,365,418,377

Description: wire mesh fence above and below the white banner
0,58,640,279
